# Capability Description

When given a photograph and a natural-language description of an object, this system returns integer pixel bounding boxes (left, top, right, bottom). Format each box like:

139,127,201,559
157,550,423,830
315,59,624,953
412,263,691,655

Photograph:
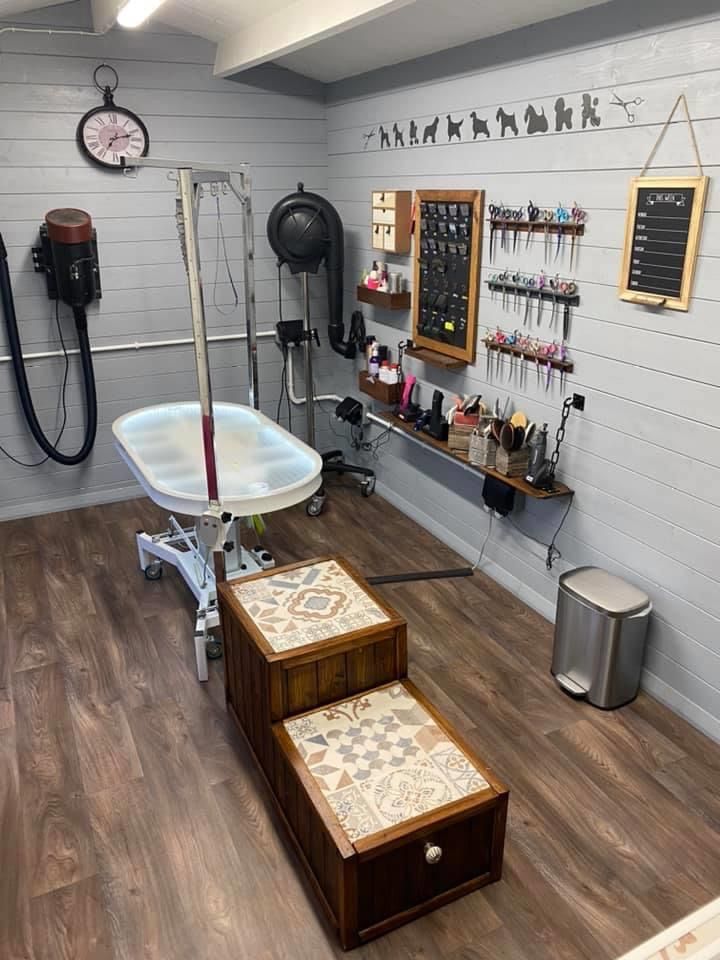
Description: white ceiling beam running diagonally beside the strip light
212,0,415,77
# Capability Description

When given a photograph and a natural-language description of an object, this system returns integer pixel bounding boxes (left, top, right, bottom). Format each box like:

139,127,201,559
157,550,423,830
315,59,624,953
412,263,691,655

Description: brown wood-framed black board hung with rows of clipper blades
413,190,485,363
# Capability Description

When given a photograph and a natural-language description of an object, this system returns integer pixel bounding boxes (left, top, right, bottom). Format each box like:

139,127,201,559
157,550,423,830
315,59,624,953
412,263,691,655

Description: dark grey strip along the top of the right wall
326,0,718,104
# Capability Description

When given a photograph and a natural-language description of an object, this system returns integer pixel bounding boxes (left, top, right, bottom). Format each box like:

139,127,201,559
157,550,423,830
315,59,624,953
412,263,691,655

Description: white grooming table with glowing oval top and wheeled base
113,402,322,680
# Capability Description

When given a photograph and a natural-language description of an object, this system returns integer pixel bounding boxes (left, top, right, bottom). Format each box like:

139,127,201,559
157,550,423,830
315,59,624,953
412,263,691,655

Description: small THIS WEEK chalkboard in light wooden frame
620,177,709,310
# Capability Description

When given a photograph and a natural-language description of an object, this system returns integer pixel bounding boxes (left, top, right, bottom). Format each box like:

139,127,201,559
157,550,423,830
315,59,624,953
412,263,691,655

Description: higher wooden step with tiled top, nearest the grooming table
218,557,407,782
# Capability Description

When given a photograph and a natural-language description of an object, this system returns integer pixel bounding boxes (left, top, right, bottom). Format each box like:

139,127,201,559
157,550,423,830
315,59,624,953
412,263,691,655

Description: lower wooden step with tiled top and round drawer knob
273,680,508,949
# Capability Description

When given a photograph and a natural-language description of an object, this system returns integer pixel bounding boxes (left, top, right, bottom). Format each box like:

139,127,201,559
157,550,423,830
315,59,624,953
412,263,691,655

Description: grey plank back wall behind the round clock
0,3,332,517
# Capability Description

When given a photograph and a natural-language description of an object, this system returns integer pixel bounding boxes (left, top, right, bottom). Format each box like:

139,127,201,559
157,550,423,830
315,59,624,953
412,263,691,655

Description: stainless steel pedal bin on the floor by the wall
551,567,652,710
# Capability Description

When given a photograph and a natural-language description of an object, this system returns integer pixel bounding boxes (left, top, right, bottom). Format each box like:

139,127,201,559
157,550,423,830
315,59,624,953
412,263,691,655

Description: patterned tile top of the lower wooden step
285,684,489,841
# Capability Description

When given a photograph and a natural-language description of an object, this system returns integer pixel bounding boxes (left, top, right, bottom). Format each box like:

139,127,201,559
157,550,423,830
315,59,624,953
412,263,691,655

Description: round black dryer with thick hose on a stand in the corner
267,183,357,359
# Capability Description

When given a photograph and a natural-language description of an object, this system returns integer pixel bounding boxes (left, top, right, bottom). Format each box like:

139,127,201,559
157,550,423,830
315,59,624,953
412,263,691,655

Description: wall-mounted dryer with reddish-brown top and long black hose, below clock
0,209,101,466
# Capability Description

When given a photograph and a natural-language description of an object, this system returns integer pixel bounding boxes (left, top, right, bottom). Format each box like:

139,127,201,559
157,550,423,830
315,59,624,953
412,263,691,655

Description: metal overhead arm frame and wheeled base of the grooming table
123,158,275,680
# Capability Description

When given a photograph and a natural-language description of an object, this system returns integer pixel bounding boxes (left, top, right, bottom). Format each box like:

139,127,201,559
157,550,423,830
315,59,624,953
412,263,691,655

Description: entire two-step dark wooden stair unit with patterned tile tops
219,557,508,949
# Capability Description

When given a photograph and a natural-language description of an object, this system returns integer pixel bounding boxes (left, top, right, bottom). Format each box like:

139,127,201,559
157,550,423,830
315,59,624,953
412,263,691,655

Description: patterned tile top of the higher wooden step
233,560,389,652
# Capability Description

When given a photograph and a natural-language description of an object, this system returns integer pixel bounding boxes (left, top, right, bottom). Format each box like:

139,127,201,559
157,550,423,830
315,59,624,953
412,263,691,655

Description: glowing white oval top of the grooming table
113,402,322,517
